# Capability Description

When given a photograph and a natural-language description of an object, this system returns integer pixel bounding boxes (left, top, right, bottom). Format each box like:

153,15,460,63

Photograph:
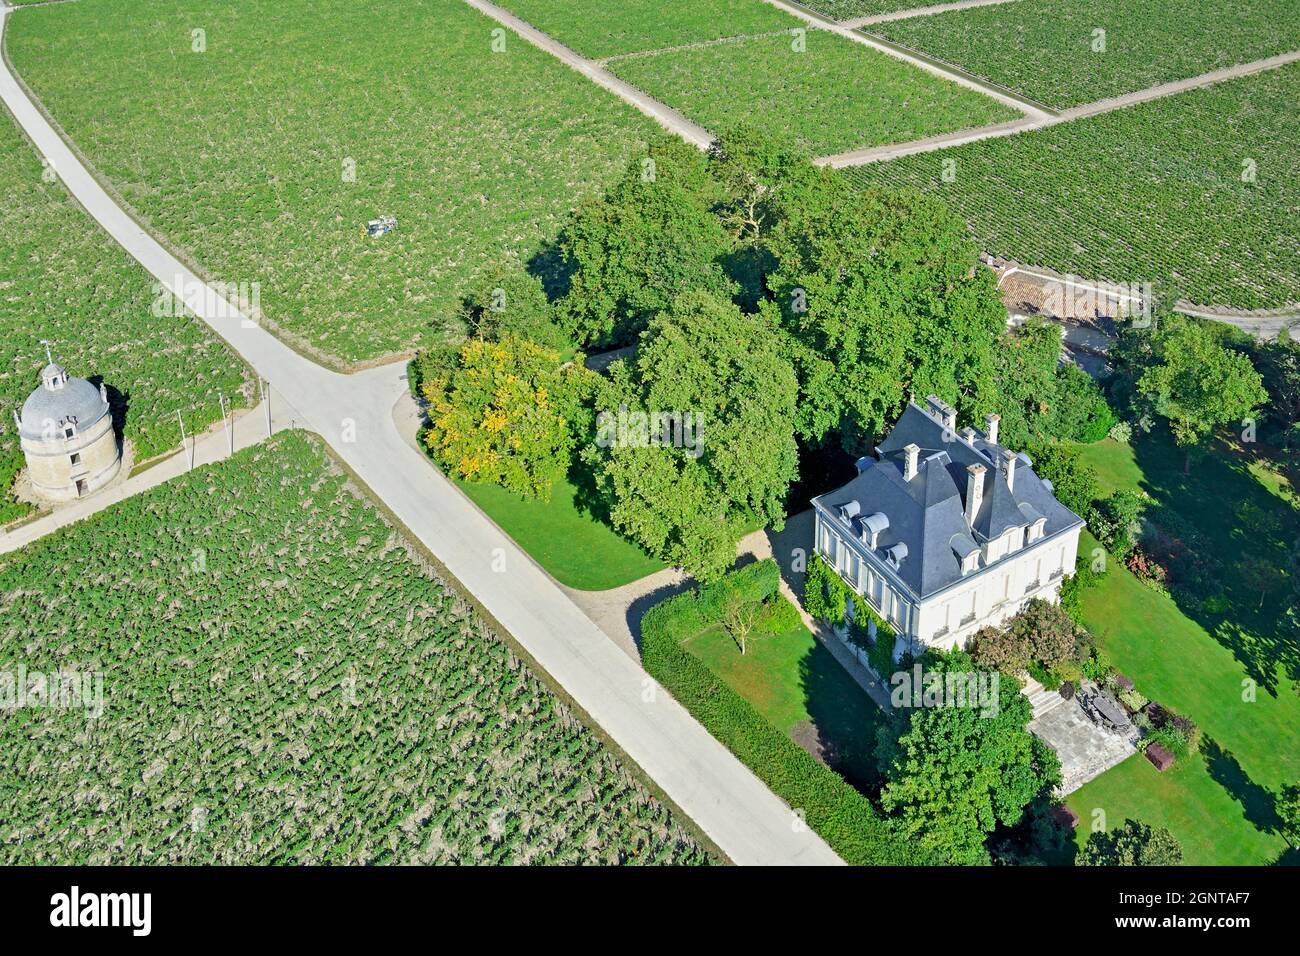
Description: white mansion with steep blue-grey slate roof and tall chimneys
813,395,1083,656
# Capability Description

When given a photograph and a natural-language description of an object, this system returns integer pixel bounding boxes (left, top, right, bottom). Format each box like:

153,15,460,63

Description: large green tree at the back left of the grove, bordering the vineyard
556,139,736,347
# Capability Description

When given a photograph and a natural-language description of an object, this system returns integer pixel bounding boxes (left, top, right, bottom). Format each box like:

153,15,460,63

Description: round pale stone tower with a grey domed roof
14,359,122,502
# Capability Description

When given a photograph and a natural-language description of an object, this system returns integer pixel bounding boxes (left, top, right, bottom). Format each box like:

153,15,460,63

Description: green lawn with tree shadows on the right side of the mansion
1069,437,1300,864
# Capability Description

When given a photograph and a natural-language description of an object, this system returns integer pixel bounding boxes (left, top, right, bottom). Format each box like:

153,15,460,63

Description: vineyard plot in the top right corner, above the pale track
871,0,1300,109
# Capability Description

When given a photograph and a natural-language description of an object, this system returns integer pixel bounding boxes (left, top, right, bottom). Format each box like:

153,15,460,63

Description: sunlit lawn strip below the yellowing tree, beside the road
456,481,664,591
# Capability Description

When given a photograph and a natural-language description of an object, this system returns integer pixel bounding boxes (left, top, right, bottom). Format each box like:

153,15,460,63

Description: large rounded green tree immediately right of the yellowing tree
586,290,798,579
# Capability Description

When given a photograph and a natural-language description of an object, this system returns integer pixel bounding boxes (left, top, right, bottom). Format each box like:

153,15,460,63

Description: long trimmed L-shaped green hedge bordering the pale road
641,559,944,866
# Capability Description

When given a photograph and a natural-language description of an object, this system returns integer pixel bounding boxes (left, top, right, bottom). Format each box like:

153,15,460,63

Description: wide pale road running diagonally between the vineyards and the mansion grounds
0,7,842,865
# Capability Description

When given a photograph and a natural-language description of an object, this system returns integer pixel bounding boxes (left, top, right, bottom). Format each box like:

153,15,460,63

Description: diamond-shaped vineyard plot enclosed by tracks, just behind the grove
610,30,1019,155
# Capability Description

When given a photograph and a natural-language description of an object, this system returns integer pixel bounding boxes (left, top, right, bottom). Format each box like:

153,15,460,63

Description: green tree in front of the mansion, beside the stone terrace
876,652,1061,864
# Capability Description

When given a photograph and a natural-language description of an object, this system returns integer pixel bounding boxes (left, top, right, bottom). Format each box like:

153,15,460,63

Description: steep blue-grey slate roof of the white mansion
814,402,1083,598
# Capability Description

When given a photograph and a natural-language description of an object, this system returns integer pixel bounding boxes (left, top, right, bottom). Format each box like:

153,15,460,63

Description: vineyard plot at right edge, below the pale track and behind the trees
849,63,1300,310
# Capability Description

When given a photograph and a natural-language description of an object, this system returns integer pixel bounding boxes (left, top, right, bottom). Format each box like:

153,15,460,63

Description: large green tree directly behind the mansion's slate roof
768,178,1006,451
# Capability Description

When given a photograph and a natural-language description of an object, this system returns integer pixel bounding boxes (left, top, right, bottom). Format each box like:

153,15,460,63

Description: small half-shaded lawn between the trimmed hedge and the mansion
683,616,881,787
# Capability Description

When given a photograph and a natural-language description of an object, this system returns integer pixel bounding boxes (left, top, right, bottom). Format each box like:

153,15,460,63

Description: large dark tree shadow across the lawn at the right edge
1134,432,1300,696
